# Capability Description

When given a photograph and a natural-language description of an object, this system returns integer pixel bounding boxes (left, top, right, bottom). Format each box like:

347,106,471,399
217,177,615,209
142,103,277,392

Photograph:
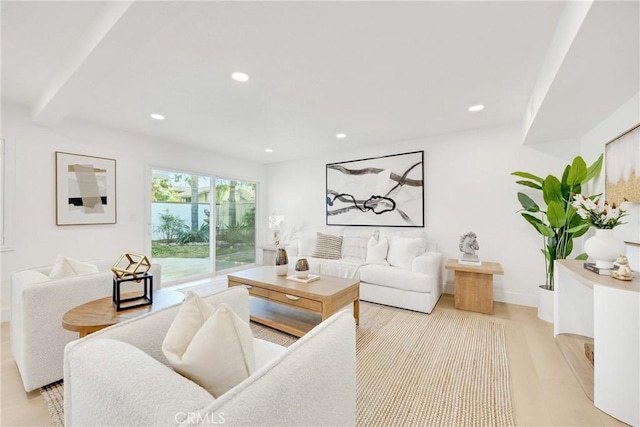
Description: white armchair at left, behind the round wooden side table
11,258,162,391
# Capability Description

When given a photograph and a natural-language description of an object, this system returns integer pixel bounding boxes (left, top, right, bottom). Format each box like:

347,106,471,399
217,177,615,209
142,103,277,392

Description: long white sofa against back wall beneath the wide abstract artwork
286,227,443,313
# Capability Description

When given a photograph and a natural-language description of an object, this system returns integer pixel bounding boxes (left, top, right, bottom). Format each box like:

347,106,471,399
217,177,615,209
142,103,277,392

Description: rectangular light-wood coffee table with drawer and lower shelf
227,266,360,337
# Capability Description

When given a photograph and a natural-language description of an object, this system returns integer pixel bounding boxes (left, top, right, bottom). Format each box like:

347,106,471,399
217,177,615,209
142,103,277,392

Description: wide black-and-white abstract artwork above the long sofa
326,151,424,227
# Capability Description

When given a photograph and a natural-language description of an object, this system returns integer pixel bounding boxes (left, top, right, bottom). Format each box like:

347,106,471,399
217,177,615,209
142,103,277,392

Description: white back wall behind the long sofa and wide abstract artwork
267,125,579,306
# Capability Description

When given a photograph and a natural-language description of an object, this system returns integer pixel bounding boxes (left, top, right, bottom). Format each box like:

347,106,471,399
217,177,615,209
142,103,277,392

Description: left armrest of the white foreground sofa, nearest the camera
64,339,214,426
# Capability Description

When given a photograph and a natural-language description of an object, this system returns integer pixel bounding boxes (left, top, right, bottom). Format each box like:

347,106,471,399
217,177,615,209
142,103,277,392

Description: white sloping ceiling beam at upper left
31,0,180,126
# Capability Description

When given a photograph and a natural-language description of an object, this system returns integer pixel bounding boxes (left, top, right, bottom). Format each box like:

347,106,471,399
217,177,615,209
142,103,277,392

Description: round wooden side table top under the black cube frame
62,289,184,338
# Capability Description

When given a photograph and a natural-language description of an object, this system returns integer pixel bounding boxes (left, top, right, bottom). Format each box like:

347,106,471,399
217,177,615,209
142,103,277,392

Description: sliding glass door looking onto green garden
151,169,256,283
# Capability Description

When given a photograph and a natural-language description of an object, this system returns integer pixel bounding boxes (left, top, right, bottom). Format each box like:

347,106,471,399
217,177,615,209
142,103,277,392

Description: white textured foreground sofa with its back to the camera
64,287,356,426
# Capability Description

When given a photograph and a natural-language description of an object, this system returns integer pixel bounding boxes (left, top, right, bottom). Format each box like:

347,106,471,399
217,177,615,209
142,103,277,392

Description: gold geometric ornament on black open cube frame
111,252,153,311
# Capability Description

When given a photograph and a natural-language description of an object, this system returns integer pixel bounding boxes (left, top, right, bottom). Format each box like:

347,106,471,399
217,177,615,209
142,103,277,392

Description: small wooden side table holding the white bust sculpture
444,259,504,314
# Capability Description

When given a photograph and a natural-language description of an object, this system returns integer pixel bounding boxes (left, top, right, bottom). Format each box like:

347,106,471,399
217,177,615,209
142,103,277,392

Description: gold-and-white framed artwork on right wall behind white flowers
604,123,640,246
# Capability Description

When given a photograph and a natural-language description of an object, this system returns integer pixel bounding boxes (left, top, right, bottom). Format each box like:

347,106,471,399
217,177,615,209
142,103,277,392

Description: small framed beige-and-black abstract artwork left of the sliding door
56,151,116,225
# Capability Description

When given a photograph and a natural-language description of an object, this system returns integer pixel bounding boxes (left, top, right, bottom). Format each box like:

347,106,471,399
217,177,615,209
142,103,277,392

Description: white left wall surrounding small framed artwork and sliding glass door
1,105,265,321
